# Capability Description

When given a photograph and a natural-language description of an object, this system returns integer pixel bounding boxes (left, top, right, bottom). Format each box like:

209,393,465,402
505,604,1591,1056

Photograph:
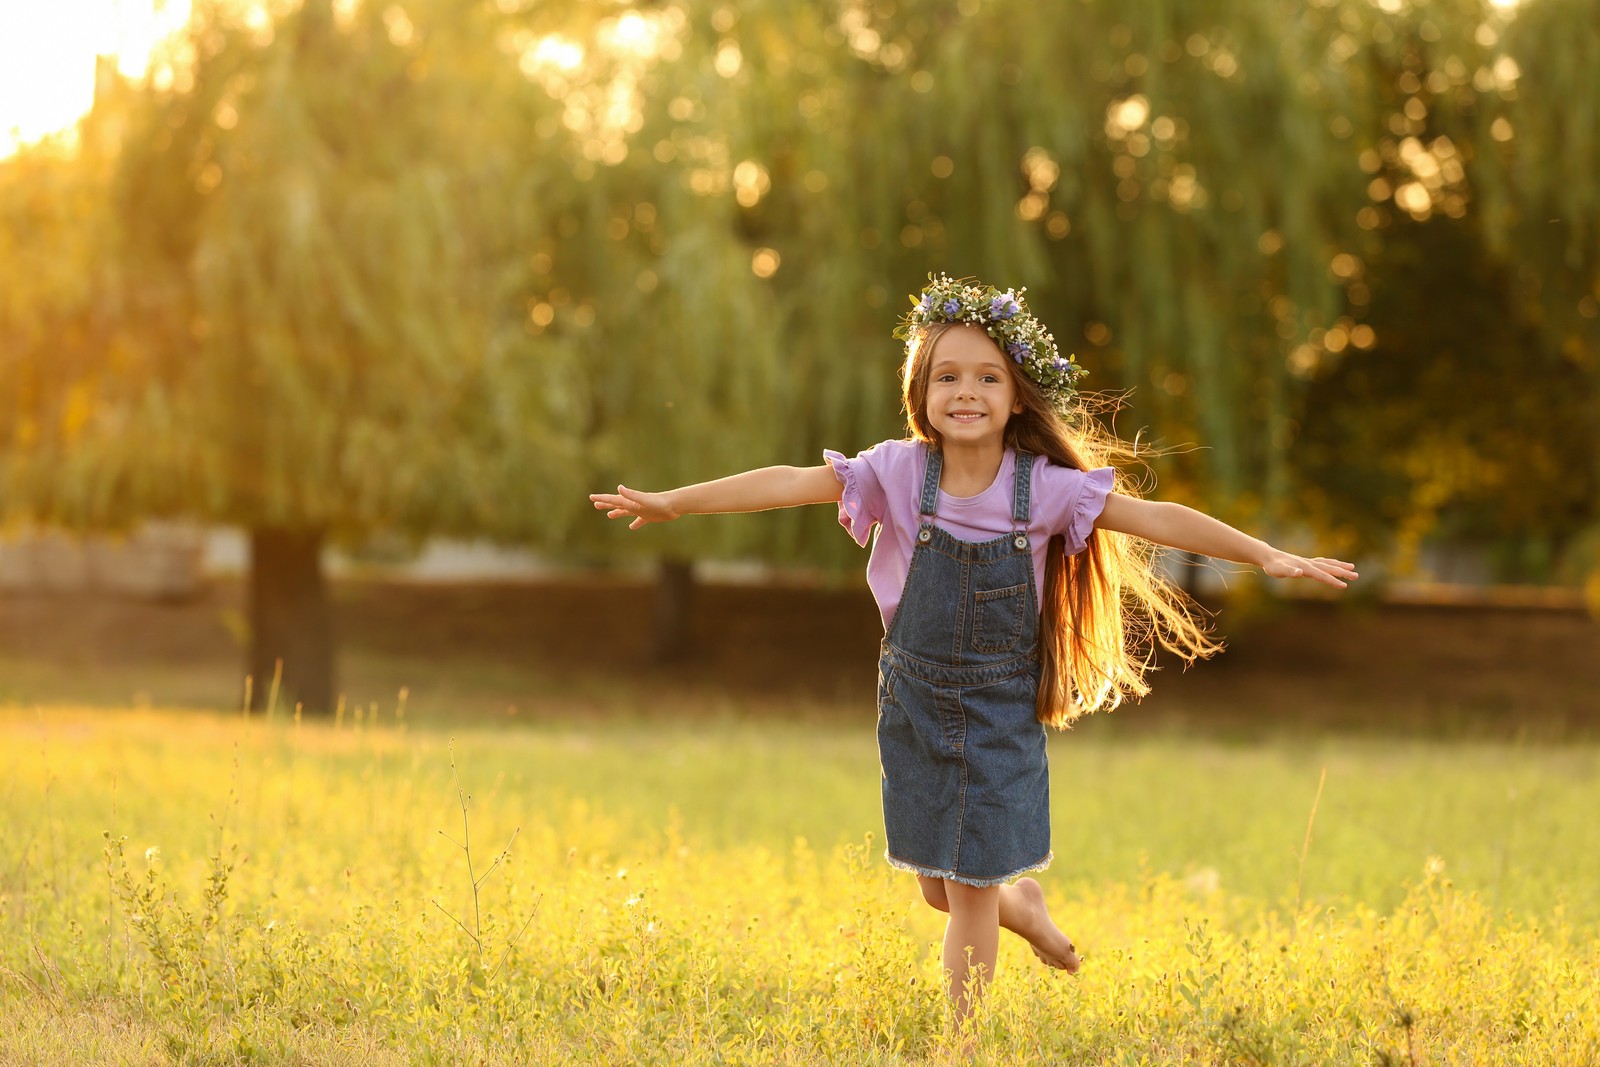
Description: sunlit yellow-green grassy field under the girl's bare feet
0,700,1600,1065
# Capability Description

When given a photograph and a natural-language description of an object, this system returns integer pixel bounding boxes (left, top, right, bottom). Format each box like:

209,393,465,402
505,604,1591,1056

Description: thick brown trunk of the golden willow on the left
248,526,333,715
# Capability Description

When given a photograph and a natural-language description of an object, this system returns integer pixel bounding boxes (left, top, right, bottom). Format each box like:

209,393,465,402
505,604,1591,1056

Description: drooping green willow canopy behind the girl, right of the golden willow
525,0,1373,591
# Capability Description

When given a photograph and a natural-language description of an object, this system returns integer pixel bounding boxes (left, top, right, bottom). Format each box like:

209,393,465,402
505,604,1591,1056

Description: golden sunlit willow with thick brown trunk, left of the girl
0,0,576,710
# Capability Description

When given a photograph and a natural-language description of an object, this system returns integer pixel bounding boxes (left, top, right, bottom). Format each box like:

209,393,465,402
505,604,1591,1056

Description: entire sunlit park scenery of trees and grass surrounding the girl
0,0,1600,1067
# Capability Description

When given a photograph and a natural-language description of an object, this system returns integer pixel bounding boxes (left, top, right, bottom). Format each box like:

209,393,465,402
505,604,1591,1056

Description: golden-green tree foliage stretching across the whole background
0,0,1600,575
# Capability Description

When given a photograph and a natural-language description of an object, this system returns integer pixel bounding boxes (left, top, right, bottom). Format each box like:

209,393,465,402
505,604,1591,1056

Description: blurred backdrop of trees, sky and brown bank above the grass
0,0,1600,731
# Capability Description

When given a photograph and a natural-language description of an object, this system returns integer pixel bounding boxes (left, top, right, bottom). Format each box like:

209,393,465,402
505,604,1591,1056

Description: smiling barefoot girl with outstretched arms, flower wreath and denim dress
589,275,1357,1022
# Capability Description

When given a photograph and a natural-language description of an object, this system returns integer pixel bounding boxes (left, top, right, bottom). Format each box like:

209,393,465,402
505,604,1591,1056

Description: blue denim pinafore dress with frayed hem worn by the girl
878,448,1051,886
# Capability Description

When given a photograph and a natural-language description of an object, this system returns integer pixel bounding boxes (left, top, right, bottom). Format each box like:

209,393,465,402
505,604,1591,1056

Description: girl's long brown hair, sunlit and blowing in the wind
901,323,1222,729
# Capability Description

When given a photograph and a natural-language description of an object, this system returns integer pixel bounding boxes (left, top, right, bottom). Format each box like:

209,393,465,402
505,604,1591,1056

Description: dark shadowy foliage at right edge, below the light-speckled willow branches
1293,218,1600,582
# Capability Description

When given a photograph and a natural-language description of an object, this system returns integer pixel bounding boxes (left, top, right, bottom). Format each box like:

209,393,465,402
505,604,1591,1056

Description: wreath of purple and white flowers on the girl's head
894,274,1086,408
